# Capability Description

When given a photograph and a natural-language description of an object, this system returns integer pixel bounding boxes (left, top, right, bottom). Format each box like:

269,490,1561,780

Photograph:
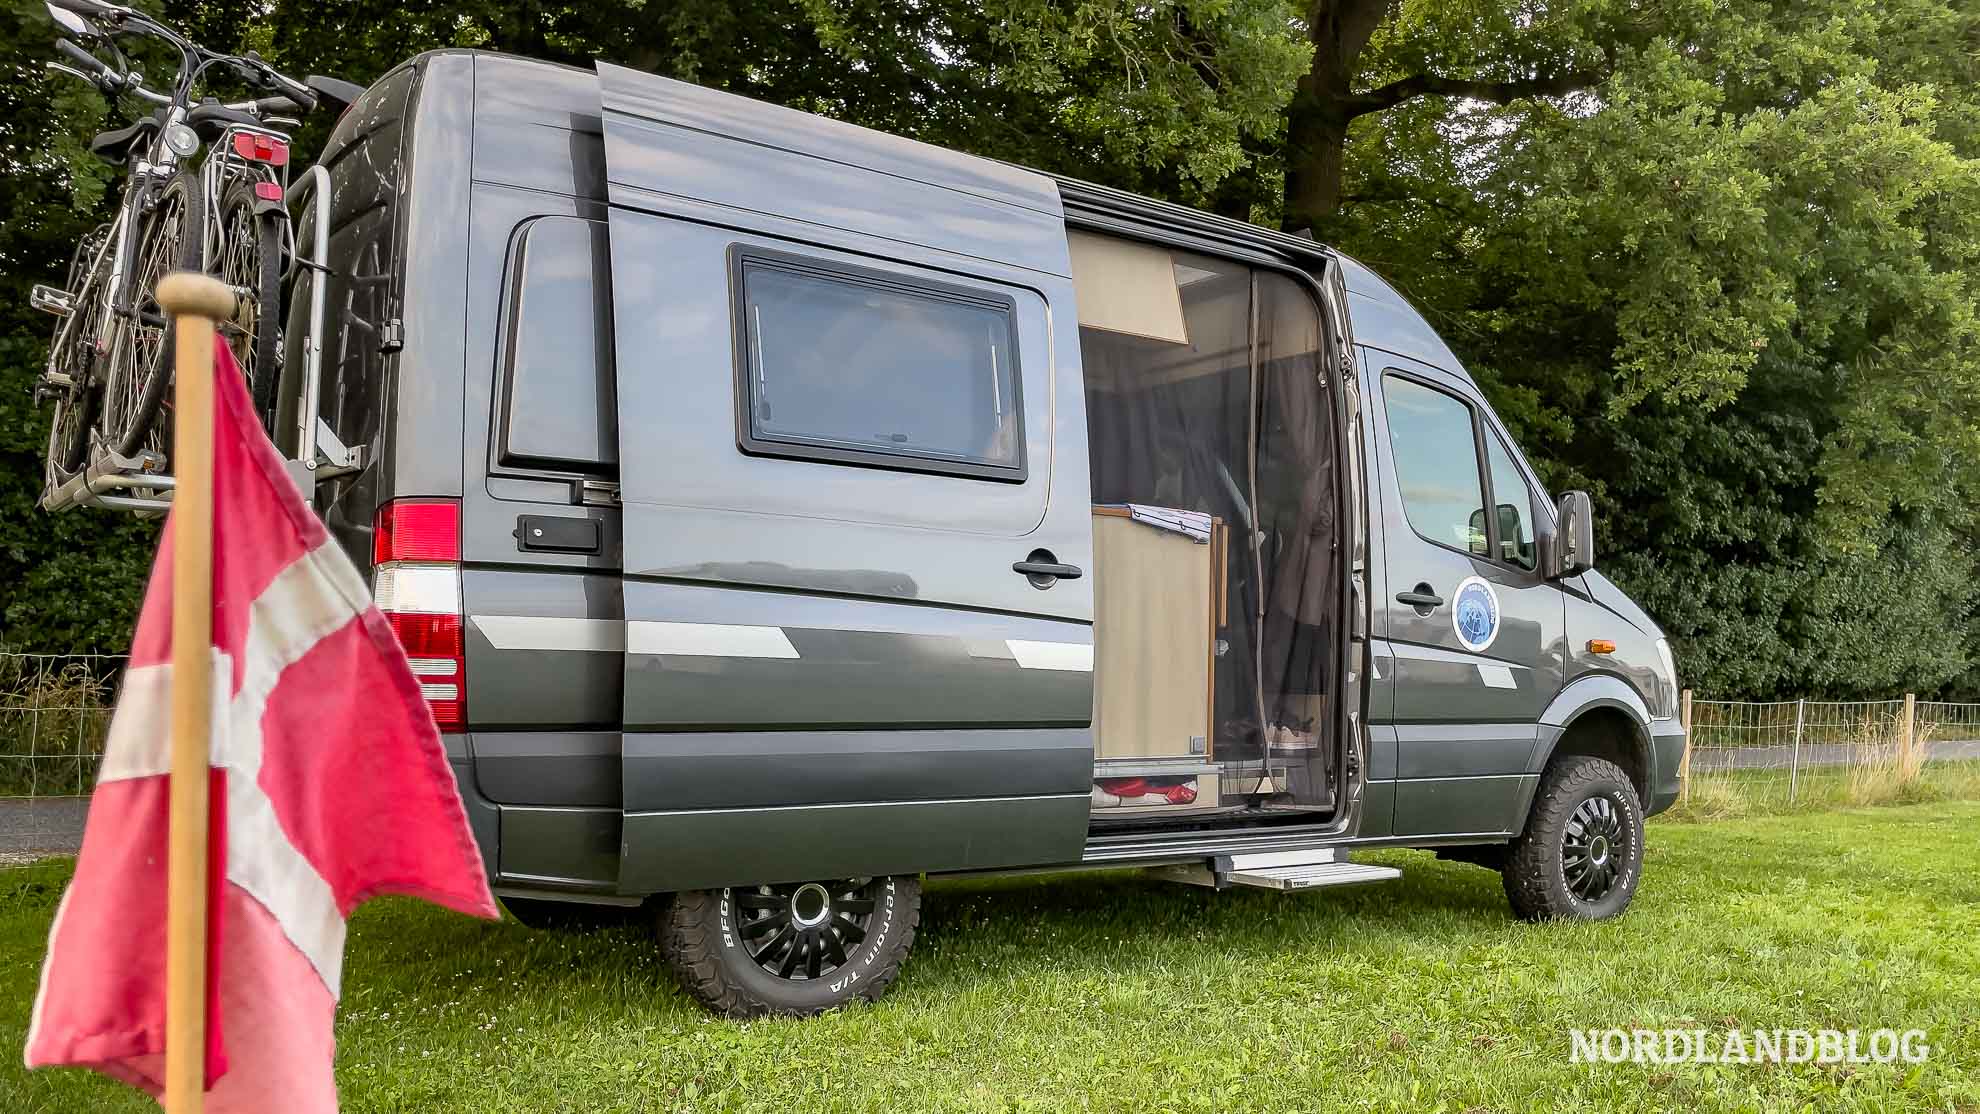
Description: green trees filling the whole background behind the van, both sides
11,0,1980,696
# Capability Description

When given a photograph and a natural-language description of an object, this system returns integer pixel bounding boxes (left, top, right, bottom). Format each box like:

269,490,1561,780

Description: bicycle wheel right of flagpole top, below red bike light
212,178,285,429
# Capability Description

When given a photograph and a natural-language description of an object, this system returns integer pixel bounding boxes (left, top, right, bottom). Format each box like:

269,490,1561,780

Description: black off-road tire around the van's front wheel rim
1503,754,1643,920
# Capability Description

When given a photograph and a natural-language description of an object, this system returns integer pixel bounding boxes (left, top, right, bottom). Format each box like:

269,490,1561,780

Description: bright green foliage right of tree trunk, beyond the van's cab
1327,0,1980,696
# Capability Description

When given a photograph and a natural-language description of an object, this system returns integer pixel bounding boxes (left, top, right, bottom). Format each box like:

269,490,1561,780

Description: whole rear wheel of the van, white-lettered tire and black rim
657,875,921,1017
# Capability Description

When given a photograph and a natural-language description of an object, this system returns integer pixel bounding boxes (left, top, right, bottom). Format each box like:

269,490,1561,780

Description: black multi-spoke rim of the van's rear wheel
729,879,881,979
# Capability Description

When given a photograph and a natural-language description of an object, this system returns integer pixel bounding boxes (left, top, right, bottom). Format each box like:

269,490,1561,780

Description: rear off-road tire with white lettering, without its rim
655,875,921,1017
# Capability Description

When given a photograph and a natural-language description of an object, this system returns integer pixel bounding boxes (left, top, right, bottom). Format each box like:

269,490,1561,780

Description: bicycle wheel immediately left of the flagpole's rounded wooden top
103,170,206,463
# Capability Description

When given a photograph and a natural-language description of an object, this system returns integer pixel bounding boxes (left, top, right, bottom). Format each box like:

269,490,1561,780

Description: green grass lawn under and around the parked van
0,801,1980,1114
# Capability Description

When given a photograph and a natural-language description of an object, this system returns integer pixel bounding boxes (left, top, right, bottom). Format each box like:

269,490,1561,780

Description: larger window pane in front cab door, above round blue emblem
1384,376,1487,556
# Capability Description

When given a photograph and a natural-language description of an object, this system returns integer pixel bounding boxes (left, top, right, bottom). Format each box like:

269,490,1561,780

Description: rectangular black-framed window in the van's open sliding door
737,255,1024,481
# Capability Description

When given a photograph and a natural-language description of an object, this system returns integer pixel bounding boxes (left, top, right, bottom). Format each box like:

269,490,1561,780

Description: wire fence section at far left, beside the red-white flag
0,653,125,797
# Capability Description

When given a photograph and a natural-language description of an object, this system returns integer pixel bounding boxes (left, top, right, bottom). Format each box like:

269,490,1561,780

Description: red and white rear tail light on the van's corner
372,499,467,732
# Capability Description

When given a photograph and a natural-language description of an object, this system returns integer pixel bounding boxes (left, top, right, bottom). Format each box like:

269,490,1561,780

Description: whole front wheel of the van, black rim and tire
1503,754,1643,920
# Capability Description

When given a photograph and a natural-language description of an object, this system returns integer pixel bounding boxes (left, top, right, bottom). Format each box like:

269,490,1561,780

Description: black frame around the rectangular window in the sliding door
729,243,1030,483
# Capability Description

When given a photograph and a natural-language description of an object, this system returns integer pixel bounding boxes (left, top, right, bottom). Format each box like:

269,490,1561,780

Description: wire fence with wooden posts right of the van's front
1683,693,1980,809
